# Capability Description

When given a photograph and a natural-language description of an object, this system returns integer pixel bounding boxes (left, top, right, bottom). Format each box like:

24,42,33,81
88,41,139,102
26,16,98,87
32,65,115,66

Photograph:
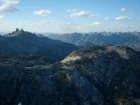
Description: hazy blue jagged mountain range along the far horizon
48,32,140,50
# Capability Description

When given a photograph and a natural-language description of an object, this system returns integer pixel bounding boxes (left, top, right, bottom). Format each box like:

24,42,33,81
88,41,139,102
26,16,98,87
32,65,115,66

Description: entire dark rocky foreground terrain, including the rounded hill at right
0,45,140,105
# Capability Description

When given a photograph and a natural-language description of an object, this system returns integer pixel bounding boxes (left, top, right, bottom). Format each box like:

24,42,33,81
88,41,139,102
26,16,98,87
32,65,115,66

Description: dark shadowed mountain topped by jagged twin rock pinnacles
0,29,78,59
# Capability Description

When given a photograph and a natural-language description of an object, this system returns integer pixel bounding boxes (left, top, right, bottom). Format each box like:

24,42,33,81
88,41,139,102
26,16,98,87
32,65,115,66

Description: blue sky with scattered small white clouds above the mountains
0,0,140,33
